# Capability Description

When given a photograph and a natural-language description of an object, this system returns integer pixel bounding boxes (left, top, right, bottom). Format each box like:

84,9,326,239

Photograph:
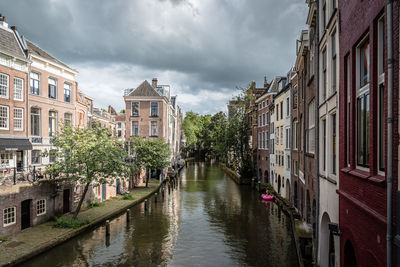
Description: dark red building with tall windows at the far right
338,0,399,266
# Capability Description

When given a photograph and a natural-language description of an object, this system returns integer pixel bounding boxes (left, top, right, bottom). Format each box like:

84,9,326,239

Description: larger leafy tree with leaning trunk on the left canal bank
47,123,130,218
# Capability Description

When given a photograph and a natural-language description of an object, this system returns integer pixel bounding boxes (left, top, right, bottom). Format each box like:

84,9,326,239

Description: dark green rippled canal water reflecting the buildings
22,162,298,267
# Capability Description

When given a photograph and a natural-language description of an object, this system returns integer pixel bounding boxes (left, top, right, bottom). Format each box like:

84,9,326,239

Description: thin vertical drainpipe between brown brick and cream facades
314,0,320,263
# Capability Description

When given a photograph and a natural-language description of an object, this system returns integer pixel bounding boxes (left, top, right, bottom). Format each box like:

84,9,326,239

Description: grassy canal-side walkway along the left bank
0,182,161,266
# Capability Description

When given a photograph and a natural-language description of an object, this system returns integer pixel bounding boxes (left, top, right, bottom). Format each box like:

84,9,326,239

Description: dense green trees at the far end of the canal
182,88,254,182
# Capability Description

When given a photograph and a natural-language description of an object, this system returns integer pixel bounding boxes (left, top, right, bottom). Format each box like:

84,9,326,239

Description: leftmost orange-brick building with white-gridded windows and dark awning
0,17,32,177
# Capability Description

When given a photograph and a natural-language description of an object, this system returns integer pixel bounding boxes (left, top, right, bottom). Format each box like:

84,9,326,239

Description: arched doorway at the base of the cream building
319,212,335,267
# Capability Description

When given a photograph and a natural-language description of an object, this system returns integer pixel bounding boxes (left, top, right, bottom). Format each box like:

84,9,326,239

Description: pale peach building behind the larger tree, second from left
25,40,78,169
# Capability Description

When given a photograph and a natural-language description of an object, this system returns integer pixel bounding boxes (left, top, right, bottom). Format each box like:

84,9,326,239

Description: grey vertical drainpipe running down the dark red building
386,0,393,267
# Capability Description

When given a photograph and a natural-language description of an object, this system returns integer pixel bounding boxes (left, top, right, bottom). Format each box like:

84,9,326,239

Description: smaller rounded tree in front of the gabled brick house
130,136,171,187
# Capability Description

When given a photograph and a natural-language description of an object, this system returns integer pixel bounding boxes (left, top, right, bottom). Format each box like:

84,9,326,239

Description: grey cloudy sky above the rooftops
0,0,307,114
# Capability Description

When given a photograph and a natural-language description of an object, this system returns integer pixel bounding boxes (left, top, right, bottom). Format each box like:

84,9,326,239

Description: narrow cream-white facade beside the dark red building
317,0,340,266
